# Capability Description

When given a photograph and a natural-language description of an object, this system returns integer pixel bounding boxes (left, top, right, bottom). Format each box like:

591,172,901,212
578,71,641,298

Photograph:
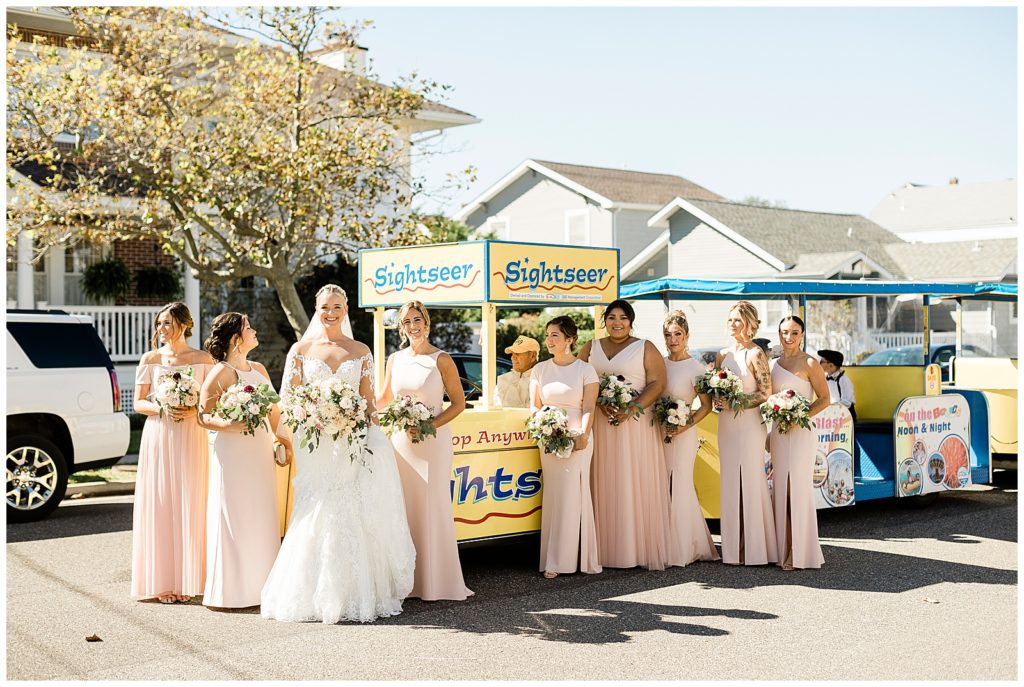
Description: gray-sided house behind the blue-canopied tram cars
621,193,1017,356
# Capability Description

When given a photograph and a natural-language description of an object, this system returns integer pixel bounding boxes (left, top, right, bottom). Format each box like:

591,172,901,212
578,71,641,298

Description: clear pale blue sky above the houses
342,7,1018,214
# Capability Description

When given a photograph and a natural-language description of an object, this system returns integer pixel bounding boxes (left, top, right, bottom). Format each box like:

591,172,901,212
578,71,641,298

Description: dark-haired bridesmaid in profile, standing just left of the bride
200,312,290,608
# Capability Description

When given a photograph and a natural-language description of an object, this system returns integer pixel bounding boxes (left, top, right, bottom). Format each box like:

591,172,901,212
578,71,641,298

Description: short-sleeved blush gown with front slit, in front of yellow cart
534,360,601,572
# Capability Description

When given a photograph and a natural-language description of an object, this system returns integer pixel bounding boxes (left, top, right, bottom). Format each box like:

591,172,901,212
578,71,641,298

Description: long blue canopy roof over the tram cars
620,277,1017,301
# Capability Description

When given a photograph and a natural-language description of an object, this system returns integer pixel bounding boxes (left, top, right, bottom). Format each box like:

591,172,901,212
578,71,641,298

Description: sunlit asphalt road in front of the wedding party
7,472,1017,680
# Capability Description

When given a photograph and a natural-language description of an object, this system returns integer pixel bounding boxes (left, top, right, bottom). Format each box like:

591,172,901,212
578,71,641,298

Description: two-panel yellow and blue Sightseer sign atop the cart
358,241,618,307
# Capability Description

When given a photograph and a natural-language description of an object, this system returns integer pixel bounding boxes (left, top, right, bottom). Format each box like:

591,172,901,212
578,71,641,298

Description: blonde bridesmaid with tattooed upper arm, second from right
715,301,778,565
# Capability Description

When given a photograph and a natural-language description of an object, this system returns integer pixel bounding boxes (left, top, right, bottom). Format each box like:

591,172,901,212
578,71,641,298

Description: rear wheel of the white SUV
7,434,68,522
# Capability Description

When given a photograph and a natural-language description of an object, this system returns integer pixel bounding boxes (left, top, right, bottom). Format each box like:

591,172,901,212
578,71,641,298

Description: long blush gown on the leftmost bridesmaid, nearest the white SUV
131,364,211,599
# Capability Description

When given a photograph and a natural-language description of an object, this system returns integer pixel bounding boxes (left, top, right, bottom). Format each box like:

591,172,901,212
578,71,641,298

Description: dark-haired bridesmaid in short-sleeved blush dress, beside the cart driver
529,315,601,579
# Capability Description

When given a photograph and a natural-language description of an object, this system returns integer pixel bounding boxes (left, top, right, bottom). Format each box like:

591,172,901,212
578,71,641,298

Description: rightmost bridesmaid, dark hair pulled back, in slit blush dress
770,315,829,570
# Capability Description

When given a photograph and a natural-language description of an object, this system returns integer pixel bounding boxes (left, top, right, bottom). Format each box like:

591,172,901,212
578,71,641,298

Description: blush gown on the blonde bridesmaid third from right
665,357,718,565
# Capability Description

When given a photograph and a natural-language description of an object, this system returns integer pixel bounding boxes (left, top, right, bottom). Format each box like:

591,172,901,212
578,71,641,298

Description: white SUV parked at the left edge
7,310,130,522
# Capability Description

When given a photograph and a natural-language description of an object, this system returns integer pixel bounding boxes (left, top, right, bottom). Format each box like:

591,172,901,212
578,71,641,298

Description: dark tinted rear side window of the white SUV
7,321,114,370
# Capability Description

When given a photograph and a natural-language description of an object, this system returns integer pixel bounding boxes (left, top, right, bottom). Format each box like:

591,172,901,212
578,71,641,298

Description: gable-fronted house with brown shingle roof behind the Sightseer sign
454,160,724,264
